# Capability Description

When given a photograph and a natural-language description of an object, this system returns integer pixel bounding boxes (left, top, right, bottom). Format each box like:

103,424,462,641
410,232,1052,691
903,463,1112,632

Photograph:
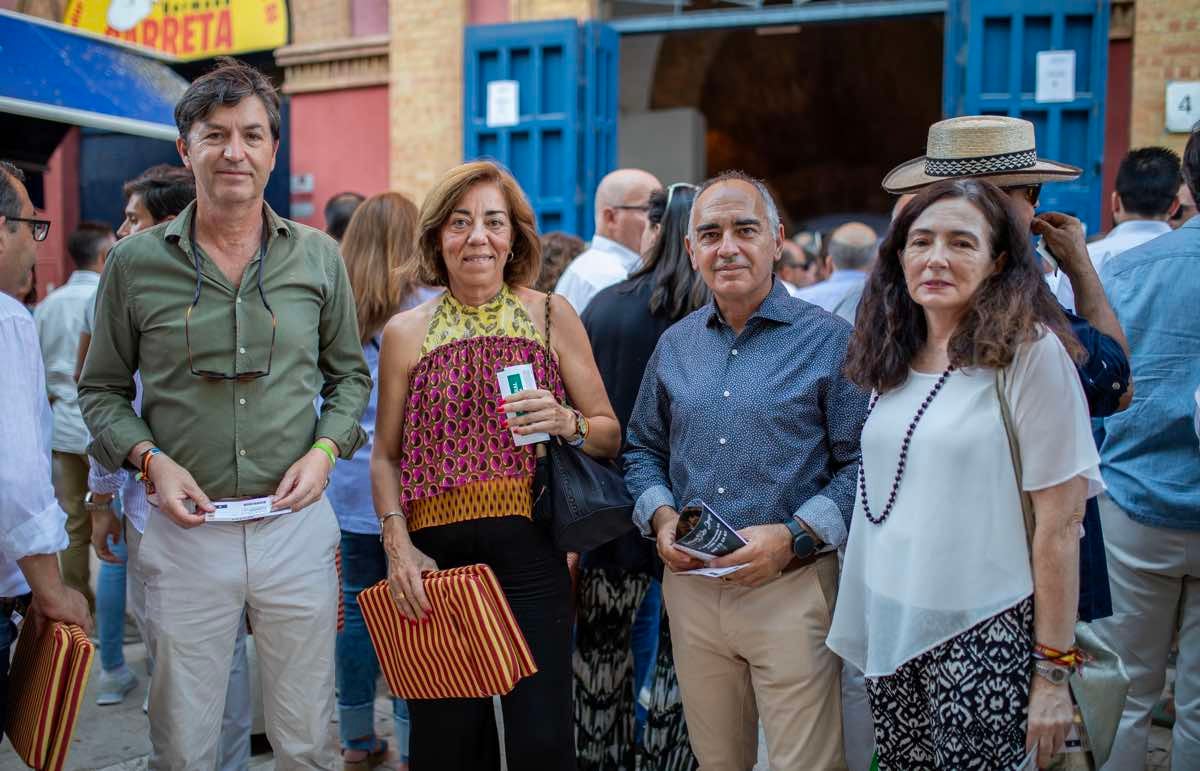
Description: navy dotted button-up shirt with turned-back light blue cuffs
625,281,868,546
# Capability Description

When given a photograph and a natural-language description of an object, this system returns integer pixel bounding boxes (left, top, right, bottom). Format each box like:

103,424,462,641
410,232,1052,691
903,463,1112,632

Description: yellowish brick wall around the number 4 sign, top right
1129,0,1200,151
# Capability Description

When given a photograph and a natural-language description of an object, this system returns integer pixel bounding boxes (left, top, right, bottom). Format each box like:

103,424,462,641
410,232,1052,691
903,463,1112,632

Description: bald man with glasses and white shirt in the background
554,168,662,313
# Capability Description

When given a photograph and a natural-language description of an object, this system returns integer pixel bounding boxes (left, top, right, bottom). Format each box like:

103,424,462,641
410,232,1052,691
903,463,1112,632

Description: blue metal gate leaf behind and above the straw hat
942,0,1109,233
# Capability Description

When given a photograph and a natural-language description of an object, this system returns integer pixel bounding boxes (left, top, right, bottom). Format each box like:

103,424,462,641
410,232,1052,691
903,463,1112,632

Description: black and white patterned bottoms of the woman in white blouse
866,598,1033,771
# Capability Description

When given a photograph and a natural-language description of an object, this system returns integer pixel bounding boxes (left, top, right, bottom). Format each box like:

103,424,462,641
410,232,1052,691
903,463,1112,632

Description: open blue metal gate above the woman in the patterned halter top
463,19,618,239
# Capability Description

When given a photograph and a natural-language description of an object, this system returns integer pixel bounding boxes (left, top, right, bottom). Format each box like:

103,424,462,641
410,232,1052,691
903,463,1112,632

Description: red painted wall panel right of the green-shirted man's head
292,85,388,229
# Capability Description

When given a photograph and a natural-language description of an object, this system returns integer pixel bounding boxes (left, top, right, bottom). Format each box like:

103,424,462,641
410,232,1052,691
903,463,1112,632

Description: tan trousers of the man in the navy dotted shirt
662,555,846,771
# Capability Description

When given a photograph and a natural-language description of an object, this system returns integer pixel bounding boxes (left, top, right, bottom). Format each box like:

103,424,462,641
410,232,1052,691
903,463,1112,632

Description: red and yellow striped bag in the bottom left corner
5,608,96,771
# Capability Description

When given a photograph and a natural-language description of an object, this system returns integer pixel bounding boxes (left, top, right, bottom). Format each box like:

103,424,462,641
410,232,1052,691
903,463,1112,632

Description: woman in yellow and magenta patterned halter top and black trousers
371,161,620,771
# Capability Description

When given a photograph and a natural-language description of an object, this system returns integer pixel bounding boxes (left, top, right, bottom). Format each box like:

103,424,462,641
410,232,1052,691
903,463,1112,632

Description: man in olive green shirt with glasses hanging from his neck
79,60,371,771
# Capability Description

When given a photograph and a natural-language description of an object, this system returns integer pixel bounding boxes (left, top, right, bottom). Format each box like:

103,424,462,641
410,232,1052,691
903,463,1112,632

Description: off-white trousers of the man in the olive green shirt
137,497,340,771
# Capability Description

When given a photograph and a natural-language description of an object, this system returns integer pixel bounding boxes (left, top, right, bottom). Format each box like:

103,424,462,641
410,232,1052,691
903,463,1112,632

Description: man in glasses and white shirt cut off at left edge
0,161,91,725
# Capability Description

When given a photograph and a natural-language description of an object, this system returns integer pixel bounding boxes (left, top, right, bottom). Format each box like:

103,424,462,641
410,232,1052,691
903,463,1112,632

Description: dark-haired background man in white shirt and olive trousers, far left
34,222,116,609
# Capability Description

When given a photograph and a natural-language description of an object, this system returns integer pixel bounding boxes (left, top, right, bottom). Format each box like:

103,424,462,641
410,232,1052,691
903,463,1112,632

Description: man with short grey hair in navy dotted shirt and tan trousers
625,172,866,769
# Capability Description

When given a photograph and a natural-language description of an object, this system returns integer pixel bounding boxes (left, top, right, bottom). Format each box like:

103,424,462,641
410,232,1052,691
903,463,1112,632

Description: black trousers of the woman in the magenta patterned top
408,516,575,771
